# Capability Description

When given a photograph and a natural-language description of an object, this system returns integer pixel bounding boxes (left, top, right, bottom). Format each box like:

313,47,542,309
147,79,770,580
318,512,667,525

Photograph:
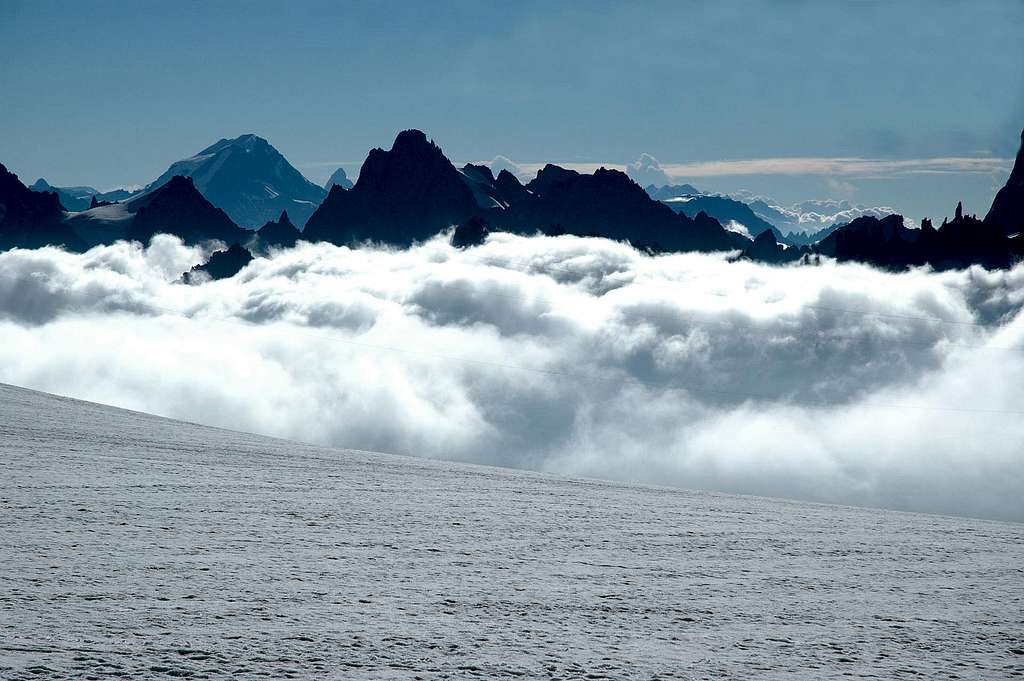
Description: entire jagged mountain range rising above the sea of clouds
0,125,1024,273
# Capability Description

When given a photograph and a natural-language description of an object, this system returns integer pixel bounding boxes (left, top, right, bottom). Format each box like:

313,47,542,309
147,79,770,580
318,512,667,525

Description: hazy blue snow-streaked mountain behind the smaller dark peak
145,134,327,229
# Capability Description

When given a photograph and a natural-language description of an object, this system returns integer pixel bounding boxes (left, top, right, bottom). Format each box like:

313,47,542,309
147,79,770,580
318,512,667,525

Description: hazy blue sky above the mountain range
0,0,1024,217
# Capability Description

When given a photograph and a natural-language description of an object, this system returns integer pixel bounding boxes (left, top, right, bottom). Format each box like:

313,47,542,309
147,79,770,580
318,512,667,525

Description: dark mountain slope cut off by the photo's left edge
0,164,86,251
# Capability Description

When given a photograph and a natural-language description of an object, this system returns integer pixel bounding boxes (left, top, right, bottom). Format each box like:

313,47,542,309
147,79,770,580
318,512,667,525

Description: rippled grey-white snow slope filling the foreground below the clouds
0,386,1024,679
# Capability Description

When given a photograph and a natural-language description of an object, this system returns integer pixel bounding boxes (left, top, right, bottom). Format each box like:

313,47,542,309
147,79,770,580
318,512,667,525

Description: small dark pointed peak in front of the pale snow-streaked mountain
126,175,252,244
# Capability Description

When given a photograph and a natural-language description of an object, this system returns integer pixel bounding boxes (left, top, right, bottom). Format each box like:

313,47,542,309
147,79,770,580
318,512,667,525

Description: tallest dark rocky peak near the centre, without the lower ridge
304,130,480,246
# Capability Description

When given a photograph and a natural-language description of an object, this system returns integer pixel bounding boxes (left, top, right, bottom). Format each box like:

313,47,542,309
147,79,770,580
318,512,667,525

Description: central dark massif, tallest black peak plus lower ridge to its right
304,130,750,251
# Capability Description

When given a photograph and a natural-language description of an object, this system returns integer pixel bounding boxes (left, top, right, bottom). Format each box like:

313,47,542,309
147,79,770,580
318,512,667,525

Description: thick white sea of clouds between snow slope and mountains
0,235,1024,520
